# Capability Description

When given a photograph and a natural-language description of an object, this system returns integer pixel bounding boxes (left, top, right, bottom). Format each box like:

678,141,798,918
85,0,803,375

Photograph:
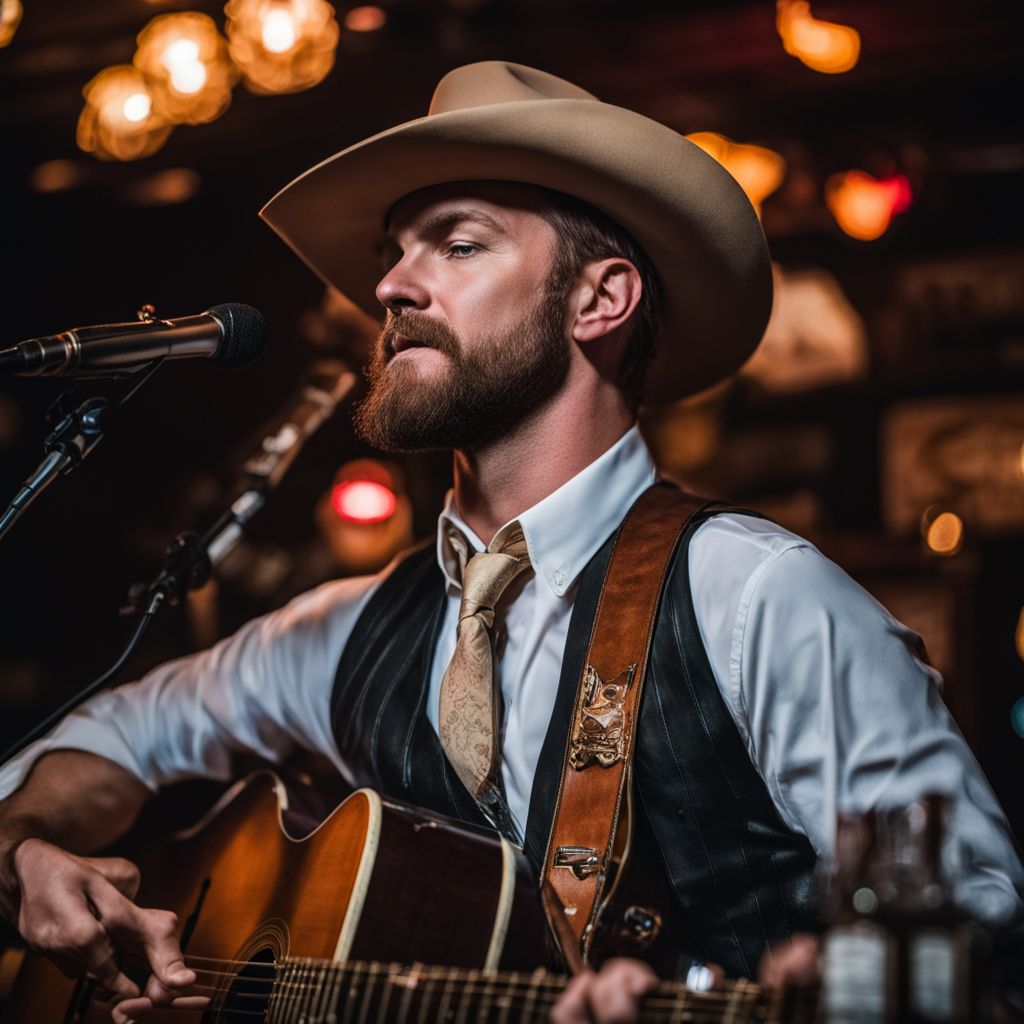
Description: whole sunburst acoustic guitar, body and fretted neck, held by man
2,772,811,1024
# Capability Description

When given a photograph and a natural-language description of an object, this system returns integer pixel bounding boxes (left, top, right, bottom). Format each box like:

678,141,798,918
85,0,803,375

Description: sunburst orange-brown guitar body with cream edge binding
3,772,546,1024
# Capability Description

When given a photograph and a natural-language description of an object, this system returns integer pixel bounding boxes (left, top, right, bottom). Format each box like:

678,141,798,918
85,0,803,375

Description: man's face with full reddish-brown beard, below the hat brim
355,182,569,452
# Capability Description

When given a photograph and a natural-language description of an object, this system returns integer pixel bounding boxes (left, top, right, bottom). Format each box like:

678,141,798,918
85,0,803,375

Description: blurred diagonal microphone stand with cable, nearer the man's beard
0,361,357,766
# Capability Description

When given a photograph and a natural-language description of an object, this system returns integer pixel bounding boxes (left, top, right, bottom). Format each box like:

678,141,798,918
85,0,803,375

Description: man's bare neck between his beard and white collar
454,382,634,544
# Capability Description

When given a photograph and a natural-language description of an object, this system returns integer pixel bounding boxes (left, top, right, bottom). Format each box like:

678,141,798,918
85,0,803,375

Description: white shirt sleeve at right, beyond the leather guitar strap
732,543,1024,924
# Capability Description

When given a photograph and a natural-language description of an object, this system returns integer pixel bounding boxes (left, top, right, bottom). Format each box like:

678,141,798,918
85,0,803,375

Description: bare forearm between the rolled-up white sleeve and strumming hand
0,751,150,918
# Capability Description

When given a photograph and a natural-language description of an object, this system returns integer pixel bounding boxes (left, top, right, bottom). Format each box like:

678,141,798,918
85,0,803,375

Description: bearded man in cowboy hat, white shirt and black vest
0,62,1024,1022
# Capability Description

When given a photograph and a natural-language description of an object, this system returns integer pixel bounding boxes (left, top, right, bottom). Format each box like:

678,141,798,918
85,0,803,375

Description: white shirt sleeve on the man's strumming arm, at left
0,577,381,798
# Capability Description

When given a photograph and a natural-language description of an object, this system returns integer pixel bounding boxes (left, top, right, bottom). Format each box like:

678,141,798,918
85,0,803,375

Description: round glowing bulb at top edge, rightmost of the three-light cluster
224,0,339,92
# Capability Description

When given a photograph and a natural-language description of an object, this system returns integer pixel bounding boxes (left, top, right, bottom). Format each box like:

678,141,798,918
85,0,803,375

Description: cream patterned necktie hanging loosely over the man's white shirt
437,525,529,842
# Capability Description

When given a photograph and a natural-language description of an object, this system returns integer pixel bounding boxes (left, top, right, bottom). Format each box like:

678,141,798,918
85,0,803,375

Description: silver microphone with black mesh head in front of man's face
0,302,266,377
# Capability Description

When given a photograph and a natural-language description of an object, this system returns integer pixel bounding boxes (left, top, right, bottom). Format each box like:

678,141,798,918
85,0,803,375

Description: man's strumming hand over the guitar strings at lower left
13,839,207,1024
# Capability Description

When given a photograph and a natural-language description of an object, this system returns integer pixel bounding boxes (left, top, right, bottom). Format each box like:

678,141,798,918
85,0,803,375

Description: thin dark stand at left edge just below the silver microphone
0,356,164,541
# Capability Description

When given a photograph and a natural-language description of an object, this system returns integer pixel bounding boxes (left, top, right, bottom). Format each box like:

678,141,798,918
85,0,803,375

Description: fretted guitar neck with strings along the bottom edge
249,959,794,1024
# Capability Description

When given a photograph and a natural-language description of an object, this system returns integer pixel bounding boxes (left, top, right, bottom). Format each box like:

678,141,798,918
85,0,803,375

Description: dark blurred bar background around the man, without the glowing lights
0,0,1024,833
